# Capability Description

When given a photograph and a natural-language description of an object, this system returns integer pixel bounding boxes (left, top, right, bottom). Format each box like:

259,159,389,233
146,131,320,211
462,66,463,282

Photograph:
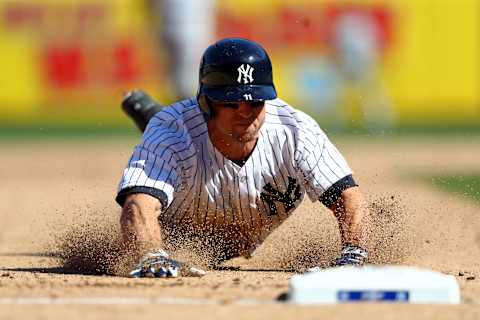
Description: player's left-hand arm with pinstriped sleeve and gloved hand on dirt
115,143,205,277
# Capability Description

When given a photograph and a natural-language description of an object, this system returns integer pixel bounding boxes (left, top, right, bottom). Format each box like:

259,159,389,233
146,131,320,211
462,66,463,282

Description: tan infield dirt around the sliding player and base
0,138,480,319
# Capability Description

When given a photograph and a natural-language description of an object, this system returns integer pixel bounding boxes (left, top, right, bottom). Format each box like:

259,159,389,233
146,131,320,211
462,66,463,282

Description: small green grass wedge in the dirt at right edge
431,174,480,204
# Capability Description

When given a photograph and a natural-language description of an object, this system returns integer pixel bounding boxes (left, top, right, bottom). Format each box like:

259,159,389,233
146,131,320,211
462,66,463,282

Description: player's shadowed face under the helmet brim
211,101,265,142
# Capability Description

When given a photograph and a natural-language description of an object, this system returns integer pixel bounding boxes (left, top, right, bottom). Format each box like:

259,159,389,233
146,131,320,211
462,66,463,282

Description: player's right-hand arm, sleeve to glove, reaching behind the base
297,117,370,265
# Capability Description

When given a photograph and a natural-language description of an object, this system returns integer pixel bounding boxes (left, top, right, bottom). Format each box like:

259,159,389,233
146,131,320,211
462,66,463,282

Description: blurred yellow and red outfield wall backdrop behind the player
0,0,480,136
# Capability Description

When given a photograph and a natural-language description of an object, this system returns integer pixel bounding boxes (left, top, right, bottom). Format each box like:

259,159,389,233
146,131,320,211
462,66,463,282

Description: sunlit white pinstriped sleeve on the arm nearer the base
296,114,353,204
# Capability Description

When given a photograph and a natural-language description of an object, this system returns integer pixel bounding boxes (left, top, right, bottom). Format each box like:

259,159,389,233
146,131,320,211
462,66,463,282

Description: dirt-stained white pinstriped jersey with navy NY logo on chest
119,99,352,254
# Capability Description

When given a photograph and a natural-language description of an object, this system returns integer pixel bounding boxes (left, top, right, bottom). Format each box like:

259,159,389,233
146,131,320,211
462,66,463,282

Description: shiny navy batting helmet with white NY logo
197,38,277,114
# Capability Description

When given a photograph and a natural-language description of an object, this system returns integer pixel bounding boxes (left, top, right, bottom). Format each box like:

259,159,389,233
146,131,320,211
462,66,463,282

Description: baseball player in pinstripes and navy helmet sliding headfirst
116,38,369,277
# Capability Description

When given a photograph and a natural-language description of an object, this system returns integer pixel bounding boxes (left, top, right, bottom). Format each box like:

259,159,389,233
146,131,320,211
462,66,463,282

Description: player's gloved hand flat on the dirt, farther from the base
130,249,206,278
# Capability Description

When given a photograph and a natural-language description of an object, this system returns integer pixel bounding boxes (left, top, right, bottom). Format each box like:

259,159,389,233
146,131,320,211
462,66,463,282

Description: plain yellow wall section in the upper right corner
384,0,480,122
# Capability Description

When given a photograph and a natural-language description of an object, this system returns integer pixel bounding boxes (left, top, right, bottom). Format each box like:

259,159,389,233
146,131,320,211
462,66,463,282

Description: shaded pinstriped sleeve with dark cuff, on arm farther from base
115,144,179,208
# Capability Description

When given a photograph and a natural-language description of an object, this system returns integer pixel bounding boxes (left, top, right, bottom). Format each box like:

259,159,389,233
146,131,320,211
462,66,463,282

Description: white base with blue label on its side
288,266,460,304
